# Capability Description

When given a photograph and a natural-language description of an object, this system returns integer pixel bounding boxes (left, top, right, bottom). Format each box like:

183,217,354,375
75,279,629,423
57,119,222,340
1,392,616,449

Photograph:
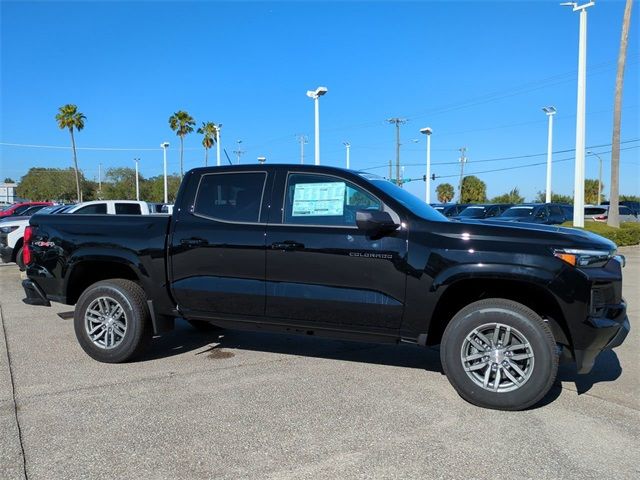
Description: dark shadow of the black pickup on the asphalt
140,320,622,409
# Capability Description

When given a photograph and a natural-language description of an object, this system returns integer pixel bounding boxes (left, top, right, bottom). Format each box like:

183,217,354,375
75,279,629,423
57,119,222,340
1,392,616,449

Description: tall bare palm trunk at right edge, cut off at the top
607,0,633,227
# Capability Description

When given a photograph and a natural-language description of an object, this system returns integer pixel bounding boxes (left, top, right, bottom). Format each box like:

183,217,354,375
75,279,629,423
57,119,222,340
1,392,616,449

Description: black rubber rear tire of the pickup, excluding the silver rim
73,279,153,363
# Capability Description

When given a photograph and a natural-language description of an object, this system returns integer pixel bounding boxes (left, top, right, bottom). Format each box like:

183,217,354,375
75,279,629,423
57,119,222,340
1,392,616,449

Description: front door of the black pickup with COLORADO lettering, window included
266,170,407,331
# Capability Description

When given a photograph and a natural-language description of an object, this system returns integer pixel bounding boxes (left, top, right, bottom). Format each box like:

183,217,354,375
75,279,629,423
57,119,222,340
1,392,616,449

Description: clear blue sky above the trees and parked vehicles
0,1,640,199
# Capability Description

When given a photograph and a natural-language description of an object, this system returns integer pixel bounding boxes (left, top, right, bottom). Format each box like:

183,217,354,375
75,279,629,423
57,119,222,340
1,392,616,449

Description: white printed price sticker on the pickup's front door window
291,182,346,217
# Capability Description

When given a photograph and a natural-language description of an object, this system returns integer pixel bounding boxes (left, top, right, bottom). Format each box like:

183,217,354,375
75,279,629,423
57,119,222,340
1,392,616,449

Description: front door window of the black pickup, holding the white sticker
283,174,382,226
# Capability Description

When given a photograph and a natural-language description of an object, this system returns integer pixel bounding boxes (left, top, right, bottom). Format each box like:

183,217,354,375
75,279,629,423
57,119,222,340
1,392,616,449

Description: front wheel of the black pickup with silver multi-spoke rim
440,298,558,410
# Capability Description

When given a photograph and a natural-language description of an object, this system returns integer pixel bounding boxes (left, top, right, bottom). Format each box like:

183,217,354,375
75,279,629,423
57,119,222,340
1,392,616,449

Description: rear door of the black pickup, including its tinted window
169,170,271,318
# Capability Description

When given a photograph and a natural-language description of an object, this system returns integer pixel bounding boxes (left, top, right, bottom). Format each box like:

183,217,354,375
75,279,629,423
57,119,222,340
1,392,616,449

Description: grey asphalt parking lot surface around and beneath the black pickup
0,247,640,480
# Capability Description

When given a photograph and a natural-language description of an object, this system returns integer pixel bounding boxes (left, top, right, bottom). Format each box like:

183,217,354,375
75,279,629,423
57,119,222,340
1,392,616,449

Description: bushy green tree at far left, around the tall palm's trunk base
16,168,85,202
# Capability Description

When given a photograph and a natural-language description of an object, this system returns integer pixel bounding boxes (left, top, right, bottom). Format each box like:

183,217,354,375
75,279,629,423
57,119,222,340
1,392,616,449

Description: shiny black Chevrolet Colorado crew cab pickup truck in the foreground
23,165,629,410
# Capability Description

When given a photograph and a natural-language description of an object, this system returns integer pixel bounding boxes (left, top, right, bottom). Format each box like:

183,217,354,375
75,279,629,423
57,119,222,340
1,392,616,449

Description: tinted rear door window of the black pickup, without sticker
193,172,267,222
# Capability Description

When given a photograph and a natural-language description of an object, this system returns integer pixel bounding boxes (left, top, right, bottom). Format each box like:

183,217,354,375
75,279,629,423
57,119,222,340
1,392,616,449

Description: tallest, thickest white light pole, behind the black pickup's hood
560,2,595,227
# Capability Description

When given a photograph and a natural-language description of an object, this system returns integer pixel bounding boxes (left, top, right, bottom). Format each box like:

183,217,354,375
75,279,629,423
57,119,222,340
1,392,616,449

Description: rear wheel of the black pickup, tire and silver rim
73,279,153,363
